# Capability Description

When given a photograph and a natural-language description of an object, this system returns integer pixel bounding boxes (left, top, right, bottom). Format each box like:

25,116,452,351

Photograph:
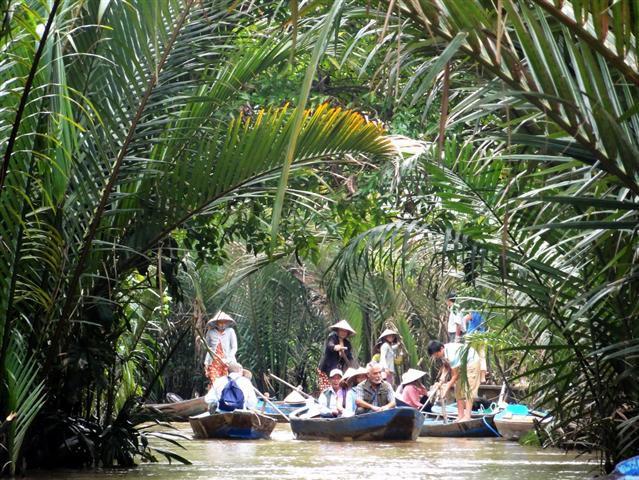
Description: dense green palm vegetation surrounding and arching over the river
0,0,639,473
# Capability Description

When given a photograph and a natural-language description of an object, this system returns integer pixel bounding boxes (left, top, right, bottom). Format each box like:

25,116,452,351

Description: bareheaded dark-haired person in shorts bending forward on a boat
427,340,479,422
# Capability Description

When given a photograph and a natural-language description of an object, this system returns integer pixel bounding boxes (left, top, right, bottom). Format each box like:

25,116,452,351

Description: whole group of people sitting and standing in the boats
205,295,486,421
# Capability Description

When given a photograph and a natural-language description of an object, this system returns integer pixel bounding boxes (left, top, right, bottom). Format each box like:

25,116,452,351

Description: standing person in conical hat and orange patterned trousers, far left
204,311,237,389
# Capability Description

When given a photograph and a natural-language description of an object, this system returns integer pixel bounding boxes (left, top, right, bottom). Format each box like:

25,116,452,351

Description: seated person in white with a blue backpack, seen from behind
204,362,257,413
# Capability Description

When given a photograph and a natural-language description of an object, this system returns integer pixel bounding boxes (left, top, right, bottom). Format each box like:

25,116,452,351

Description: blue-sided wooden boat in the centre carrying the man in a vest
290,407,424,441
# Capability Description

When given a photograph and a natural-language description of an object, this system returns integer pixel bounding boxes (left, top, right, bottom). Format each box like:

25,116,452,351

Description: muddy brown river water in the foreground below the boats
22,424,596,480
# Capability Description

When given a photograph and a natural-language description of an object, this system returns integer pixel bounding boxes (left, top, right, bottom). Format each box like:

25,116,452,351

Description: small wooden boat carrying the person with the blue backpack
189,410,277,440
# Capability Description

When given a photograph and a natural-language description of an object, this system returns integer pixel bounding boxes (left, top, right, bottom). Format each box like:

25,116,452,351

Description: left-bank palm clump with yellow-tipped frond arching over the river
0,0,396,468
